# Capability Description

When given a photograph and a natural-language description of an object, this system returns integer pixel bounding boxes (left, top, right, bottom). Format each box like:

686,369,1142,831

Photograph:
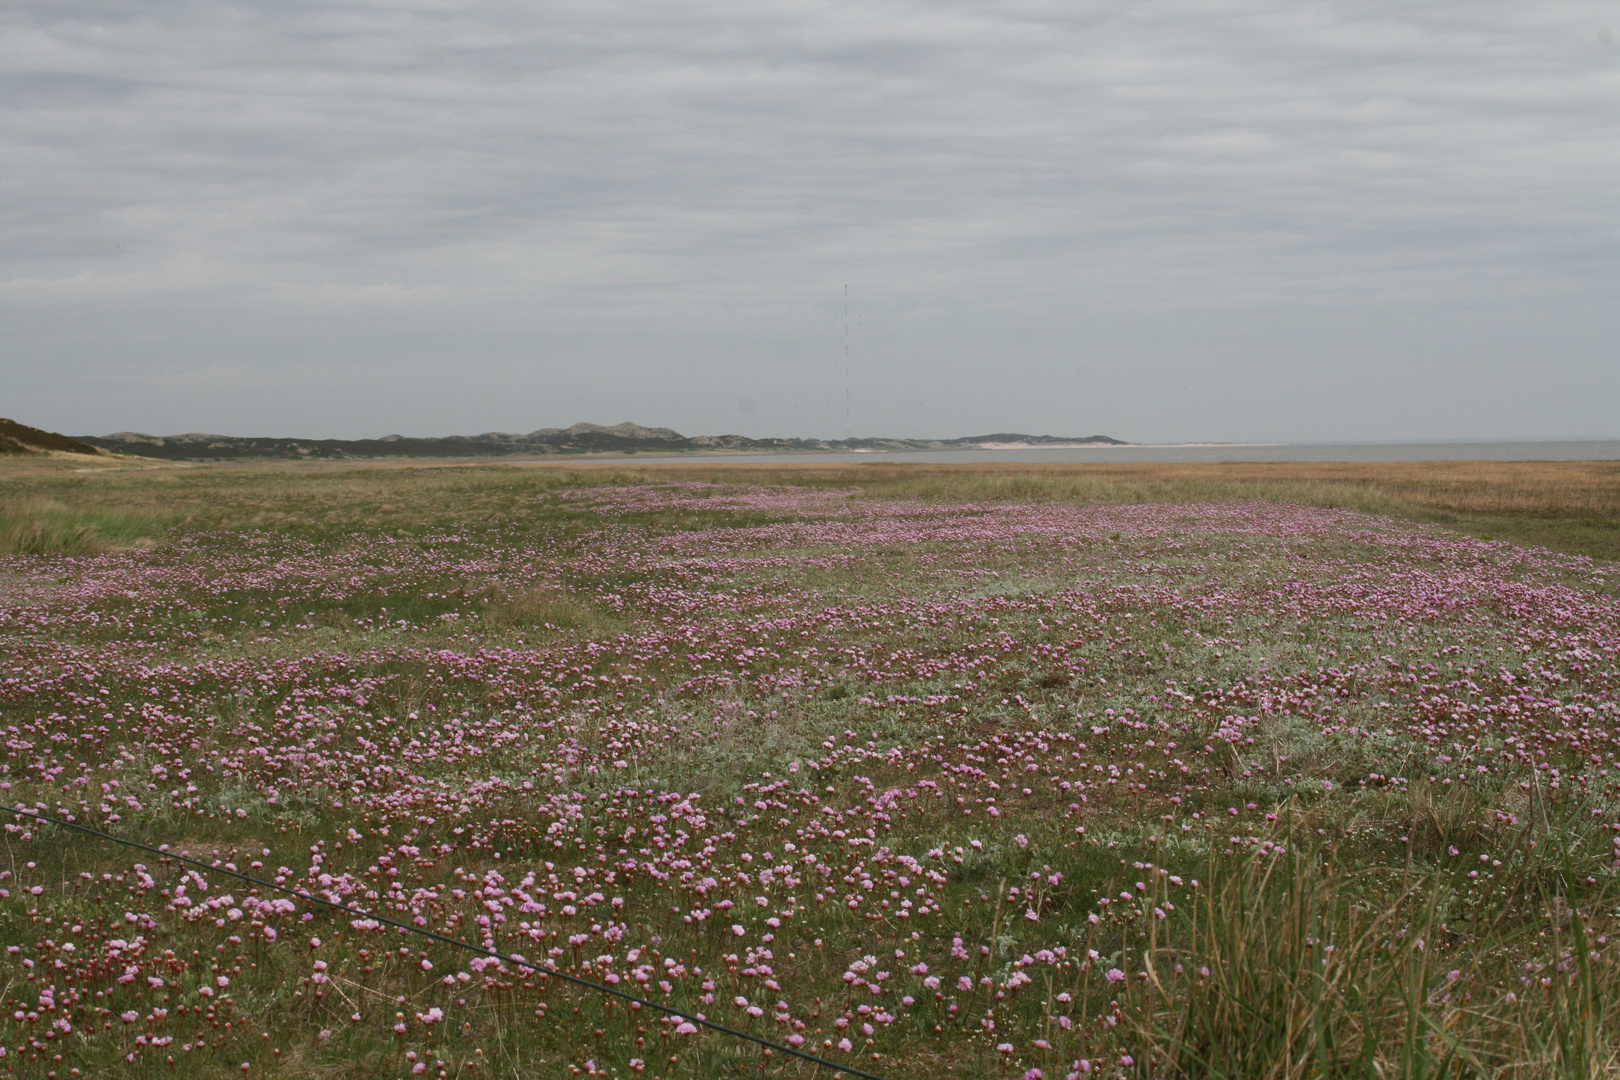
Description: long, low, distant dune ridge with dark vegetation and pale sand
66,421,1124,460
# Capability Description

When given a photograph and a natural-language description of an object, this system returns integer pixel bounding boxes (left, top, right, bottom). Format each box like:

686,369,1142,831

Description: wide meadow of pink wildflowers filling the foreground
0,478,1620,1080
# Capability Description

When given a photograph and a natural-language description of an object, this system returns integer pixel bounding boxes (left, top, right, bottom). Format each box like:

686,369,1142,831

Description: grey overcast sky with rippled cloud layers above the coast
0,0,1620,440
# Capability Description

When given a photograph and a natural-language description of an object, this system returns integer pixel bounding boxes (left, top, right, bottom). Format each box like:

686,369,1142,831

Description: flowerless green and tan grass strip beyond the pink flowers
0,460,1620,560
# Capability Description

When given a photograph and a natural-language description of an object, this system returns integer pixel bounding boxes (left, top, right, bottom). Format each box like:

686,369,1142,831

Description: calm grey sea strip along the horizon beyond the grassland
514,439,1620,465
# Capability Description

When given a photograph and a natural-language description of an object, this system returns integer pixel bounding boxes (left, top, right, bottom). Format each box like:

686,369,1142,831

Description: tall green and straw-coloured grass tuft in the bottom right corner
1110,816,1620,1080
